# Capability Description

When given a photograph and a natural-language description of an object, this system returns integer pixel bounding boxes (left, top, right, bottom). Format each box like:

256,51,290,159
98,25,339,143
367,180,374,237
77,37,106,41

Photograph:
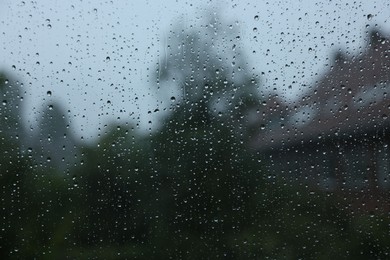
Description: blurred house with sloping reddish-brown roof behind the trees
252,31,390,211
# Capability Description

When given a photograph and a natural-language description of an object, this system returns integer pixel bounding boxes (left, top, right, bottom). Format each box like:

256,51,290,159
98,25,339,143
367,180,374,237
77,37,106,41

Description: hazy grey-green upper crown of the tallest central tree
156,14,262,142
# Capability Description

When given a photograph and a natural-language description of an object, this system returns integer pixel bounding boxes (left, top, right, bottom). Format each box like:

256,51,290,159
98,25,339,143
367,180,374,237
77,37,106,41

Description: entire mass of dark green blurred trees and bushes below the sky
0,23,390,259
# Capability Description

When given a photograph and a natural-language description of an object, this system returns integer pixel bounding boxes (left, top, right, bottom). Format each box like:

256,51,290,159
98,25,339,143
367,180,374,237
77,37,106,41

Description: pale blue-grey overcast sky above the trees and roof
0,0,390,140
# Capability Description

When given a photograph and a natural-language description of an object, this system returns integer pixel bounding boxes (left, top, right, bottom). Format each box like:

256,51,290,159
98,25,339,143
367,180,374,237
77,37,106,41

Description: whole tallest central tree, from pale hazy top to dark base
152,14,262,258
